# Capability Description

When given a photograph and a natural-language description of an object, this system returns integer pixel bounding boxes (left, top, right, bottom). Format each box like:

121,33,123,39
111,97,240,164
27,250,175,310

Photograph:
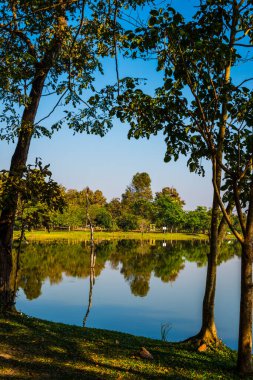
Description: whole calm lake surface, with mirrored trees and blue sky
16,240,240,348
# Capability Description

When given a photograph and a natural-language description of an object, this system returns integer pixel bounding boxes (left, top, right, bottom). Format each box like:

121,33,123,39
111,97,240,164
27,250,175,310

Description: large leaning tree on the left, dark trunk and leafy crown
0,0,146,306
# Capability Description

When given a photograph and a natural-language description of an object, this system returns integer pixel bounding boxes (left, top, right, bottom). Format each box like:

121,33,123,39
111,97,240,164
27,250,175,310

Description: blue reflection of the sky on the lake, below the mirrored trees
16,258,240,348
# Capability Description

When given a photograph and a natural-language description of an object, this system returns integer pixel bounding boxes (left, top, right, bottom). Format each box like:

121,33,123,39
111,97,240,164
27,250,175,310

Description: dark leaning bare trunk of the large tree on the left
0,8,67,302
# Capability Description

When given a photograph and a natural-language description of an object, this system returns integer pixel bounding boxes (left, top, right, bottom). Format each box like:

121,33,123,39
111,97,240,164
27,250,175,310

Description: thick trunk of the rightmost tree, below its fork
237,241,253,374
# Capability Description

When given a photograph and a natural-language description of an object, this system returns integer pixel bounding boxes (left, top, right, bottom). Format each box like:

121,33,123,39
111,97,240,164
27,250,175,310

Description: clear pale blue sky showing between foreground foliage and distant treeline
0,0,245,209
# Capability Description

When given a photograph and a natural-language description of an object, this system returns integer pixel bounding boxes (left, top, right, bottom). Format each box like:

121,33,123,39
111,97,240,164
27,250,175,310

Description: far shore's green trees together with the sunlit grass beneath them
12,173,238,240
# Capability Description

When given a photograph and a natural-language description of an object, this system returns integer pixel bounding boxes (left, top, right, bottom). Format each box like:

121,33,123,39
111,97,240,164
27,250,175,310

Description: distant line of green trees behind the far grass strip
16,173,239,233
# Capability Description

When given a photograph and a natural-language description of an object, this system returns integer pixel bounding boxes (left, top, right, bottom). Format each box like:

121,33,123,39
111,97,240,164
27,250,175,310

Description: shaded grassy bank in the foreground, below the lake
0,314,247,380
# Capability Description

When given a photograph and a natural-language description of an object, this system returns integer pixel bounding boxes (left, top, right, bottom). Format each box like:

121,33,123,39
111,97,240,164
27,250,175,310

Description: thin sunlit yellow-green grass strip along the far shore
14,231,207,241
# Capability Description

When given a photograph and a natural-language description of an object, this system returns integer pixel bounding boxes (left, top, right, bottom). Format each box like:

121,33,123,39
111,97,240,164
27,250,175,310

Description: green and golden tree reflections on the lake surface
12,240,240,300
